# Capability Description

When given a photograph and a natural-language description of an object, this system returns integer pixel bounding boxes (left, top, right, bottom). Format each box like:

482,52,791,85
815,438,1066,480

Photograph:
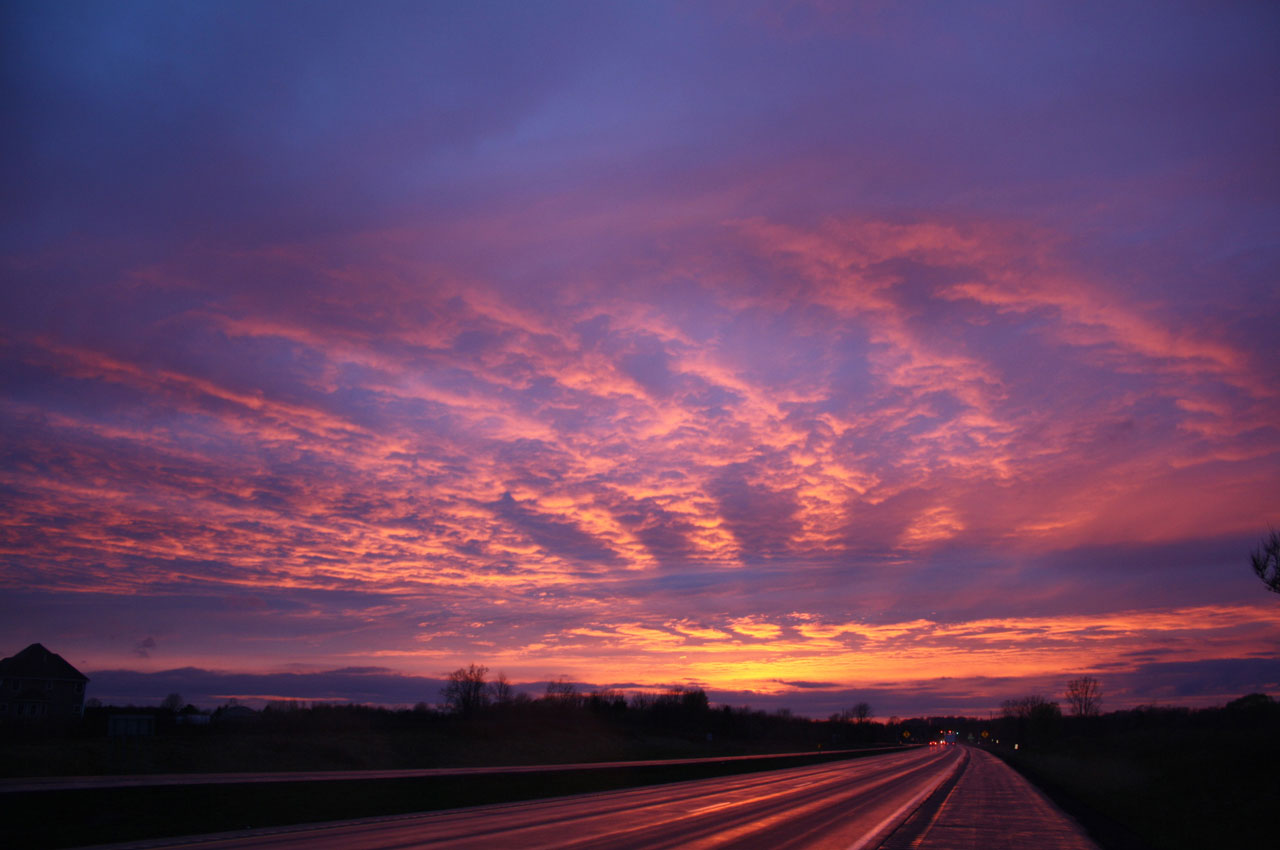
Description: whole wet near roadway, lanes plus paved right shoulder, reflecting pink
10,746,1097,850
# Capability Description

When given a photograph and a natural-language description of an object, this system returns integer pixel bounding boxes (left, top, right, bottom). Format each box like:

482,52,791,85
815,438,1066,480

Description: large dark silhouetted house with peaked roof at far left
0,644,88,721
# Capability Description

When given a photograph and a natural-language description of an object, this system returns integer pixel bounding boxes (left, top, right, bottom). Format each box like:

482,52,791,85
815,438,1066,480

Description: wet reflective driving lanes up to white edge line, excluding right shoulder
99,748,965,850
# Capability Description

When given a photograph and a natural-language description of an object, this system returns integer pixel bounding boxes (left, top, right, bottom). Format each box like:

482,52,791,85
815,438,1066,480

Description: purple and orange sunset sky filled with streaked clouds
0,0,1280,718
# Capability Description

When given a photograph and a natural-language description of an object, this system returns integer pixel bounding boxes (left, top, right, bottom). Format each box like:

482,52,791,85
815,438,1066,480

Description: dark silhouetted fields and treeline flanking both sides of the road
0,695,1280,850
